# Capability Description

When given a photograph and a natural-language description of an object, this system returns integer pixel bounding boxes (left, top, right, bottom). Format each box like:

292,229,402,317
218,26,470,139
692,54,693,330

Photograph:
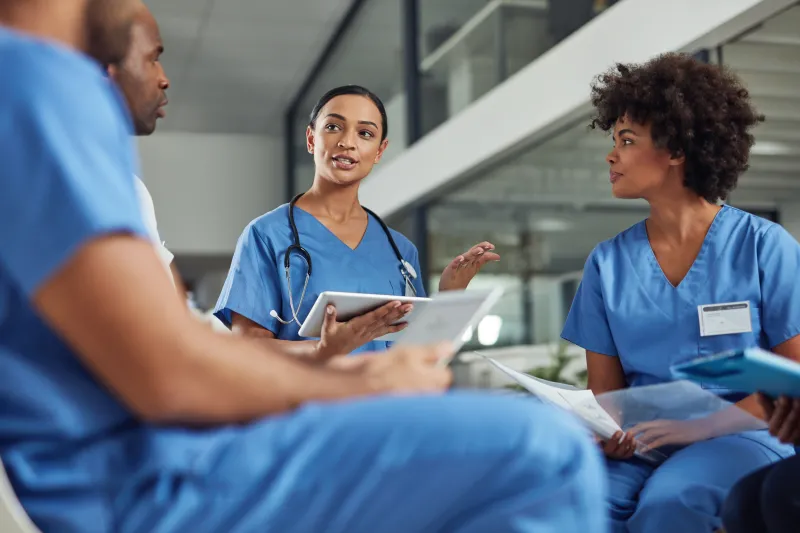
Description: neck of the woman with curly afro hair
647,188,721,243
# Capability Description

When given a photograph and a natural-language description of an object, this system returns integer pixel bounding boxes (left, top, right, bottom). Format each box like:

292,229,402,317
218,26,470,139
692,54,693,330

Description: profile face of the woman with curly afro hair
606,117,684,199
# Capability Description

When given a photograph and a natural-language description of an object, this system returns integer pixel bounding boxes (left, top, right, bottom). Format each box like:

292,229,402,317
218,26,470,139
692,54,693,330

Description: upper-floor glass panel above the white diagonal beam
419,0,628,137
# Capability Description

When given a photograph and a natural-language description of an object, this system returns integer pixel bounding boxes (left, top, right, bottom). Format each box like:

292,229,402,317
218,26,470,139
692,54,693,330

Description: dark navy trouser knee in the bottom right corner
722,448,800,533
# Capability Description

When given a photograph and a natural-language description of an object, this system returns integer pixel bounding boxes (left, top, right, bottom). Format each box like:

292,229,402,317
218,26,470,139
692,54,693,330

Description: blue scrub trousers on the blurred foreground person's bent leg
109,393,607,533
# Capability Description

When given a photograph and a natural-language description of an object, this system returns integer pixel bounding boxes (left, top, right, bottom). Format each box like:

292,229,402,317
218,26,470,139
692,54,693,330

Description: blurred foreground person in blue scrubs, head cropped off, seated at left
0,0,605,533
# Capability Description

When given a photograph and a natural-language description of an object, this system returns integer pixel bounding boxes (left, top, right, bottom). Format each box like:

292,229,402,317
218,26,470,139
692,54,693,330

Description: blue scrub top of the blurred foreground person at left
0,28,230,531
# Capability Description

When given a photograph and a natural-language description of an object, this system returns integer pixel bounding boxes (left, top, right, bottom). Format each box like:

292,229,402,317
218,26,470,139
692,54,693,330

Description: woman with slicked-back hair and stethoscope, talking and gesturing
214,85,500,359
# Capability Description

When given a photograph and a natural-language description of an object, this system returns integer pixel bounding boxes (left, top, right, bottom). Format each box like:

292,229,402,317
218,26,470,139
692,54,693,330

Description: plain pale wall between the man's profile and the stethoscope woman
139,132,285,255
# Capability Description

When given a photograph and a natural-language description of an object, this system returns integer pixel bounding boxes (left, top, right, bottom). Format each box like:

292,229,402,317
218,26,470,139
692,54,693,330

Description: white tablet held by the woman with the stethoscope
298,291,431,341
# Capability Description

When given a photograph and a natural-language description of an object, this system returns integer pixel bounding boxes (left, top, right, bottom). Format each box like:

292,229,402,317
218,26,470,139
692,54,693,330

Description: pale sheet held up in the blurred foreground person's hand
395,288,503,354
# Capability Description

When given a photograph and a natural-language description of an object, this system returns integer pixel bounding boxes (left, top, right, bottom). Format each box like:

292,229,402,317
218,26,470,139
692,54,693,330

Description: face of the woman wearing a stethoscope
306,94,388,185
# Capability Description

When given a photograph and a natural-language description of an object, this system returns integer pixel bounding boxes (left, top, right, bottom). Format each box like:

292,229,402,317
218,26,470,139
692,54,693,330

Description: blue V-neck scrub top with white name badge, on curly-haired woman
562,206,800,395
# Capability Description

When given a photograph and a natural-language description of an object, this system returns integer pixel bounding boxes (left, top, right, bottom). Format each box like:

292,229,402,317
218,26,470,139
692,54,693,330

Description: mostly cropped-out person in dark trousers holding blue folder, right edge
722,395,800,533
